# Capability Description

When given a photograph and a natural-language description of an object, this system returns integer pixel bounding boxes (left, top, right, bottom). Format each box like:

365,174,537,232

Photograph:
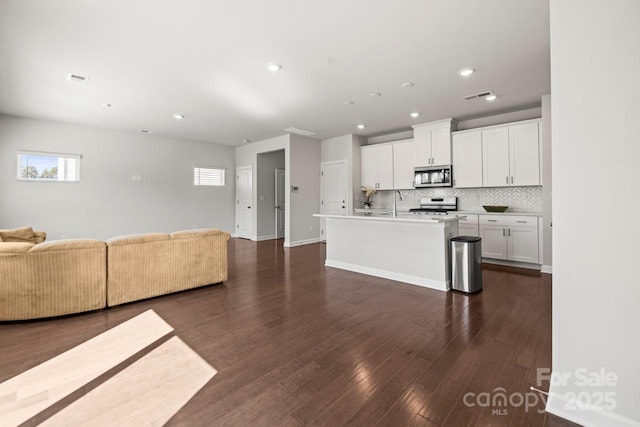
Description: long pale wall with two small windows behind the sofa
0,116,235,240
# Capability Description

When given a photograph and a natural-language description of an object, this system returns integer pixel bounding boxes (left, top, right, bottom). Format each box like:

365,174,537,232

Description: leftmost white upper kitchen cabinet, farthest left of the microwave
360,144,393,190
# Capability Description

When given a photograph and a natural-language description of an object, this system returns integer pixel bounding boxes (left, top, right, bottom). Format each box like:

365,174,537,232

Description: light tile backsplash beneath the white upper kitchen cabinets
368,186,542,212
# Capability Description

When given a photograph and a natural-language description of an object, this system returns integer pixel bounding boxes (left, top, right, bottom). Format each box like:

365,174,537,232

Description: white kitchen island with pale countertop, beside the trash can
314,213,459,291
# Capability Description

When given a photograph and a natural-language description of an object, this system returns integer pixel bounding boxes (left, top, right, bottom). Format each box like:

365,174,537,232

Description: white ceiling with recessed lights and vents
0,0,550,145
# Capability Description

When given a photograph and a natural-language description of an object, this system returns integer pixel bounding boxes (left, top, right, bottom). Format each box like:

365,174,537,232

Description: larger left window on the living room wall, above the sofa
17,151,82,182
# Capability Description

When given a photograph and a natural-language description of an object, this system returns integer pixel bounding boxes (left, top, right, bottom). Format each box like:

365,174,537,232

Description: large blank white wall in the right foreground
547,0,640,426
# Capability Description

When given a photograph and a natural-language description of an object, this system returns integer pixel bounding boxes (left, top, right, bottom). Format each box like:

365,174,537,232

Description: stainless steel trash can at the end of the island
451,236,482,294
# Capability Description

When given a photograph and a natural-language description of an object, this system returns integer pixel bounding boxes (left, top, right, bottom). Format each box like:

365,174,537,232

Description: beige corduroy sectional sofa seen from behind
0,229,230,321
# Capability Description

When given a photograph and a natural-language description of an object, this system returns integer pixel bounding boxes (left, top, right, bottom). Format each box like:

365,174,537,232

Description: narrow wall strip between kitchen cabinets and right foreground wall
540,95,553,273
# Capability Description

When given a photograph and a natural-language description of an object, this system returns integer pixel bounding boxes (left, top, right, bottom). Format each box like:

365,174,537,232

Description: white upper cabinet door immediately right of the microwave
453,132,482,188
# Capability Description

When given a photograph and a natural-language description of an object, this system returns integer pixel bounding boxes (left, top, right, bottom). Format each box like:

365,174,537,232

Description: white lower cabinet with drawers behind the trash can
479,215,539,264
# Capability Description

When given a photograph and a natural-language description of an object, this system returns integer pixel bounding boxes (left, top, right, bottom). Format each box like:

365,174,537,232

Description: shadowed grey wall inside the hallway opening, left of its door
255,150,286,240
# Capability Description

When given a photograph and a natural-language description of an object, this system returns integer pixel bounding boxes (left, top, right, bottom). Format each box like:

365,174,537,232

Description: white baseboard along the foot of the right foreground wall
545,387,640,427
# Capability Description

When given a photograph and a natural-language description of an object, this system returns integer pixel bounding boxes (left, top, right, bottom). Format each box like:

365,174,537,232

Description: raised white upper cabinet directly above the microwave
413,119,456,167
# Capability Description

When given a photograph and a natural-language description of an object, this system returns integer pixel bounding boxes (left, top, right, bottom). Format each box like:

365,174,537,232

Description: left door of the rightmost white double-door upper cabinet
480,127,510,187
